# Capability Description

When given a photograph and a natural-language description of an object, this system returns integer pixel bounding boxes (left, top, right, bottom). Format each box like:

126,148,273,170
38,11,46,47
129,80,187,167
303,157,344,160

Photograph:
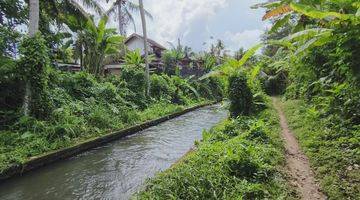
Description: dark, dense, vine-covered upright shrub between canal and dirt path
228,73,253,117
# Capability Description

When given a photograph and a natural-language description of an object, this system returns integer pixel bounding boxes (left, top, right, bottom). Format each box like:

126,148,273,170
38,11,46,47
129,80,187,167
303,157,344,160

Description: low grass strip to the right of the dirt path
284,100,360,200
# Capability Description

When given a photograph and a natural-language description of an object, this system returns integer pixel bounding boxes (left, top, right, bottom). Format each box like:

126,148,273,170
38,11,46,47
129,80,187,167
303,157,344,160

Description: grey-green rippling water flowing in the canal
0,105,227,200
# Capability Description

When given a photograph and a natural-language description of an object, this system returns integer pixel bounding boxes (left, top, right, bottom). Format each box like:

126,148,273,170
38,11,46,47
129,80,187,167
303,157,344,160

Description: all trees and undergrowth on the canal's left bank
0,0,223,172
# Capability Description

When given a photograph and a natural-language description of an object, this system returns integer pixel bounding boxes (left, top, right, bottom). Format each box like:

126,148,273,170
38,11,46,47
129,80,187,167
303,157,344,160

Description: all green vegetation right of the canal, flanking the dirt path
139,0,360,199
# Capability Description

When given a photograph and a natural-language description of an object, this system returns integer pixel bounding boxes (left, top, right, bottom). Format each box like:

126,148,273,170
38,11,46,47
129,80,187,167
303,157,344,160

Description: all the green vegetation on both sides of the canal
0,0,360,200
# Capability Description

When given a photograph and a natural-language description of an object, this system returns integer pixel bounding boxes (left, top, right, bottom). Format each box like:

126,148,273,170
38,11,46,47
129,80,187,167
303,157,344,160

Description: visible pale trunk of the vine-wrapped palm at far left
23,0,39,116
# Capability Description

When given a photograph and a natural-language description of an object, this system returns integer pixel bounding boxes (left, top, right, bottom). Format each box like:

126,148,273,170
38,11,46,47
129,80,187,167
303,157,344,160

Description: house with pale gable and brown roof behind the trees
104,33,166,75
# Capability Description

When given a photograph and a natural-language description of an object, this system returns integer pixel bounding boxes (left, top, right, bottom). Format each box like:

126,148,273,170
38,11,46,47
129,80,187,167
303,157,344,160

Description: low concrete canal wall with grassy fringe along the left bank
0,101,215,181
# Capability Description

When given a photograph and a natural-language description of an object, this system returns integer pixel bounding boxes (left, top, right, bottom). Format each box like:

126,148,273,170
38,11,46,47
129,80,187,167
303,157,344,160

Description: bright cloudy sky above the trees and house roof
100,0,268,52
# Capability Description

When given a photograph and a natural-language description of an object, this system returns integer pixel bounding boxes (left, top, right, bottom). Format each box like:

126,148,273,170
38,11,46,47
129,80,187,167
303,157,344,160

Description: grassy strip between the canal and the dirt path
134,101,296,199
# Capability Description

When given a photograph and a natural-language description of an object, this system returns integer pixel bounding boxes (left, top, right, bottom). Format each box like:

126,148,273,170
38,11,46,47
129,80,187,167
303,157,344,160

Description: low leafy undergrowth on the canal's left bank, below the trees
0,67,221,171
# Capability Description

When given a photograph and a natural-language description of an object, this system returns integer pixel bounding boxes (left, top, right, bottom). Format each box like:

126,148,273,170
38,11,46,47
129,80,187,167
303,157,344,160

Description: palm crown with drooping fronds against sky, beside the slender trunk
105,0,152,36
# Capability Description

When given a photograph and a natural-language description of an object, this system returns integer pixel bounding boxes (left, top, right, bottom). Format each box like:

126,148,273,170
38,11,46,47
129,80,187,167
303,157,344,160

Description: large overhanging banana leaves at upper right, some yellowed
200,0,360,86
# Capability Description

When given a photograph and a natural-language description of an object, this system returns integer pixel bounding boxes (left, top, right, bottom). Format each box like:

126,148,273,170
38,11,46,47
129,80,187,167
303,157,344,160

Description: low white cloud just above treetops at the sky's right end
223,29,264,51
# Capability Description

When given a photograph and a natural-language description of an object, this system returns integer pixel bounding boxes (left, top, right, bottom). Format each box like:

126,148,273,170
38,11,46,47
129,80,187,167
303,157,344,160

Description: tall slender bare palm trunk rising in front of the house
139,0,150,96
